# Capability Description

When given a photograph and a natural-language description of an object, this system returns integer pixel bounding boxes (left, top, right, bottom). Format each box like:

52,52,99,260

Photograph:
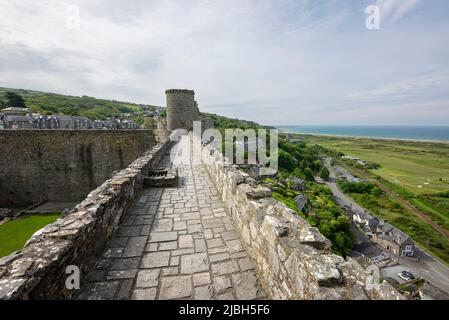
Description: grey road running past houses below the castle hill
326,163,449,293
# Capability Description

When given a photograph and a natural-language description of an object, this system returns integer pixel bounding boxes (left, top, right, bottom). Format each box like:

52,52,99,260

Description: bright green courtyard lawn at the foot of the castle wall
0,213,60,258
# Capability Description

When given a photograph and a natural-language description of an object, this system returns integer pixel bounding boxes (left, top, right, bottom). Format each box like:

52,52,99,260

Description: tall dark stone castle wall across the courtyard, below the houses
0,130,156,207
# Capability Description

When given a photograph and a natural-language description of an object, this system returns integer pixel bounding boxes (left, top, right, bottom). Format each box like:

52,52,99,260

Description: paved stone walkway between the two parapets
78,139,265,300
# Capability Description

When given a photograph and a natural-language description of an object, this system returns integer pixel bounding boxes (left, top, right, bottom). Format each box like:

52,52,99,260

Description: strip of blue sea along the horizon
276,125,449,142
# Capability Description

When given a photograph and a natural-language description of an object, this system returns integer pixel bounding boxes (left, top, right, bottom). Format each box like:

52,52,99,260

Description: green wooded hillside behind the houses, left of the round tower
0,87,161,123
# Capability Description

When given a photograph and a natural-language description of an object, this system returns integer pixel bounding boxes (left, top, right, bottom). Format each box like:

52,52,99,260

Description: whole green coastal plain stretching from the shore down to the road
301,135,449,263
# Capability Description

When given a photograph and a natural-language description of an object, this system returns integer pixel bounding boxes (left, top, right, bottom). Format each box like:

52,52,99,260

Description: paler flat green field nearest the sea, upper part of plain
305,136,449,194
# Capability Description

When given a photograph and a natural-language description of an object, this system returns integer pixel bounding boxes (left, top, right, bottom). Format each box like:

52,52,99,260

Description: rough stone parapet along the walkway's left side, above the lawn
0,140,171,299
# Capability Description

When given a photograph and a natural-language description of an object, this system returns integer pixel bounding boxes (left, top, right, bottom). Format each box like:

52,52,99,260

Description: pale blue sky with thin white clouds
0,0,449,125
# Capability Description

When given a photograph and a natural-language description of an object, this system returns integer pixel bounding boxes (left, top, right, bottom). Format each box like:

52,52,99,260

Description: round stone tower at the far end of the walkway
165,89,199,131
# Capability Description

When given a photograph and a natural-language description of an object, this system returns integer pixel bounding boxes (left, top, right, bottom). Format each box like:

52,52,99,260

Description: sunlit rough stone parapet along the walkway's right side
198,138,402,300
